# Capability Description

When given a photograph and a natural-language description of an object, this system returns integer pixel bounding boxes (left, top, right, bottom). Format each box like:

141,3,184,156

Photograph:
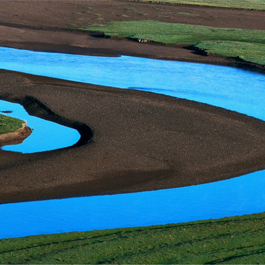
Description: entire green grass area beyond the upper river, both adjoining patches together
81,20,265,65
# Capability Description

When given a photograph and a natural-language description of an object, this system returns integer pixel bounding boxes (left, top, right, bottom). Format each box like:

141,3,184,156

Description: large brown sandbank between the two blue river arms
0,71,265,203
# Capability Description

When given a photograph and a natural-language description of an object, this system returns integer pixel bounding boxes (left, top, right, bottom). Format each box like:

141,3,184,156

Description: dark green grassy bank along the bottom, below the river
0,213,265,264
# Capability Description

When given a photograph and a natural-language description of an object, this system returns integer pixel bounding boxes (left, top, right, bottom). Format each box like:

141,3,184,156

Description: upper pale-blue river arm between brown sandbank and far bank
0,47,265,120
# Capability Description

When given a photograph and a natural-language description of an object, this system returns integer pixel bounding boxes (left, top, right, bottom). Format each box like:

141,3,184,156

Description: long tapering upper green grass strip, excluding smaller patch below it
83,20,265,44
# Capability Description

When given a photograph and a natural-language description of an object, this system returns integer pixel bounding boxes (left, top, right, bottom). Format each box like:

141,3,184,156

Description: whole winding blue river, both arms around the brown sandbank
0,48,265,238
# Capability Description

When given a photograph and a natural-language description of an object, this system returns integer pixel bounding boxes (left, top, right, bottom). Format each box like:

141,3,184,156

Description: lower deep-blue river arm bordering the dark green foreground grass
0,171,265,238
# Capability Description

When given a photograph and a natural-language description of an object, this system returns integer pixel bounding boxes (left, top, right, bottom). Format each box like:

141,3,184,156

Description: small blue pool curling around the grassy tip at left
0,100,80,153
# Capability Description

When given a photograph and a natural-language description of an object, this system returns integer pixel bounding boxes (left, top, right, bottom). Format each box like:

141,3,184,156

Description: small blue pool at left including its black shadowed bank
0,95,94,154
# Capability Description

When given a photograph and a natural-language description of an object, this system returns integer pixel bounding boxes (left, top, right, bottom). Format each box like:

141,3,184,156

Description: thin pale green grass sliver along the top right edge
143,0,265,10
